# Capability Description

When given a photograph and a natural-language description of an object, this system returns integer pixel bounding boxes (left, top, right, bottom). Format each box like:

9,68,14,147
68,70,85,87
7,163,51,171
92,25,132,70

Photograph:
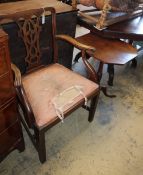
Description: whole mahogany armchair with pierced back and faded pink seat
0,7,99,163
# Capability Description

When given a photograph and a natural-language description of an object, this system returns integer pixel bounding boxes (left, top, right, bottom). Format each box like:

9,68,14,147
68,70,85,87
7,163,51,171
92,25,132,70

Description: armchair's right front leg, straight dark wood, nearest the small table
88,92,100,122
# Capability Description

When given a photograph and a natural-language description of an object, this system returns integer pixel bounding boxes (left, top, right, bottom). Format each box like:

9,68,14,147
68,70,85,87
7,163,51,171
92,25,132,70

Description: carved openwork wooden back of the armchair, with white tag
0,7,57,72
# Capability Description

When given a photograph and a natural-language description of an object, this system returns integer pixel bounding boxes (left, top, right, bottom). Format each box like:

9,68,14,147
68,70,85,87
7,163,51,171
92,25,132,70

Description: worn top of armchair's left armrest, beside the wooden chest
11,63,21,87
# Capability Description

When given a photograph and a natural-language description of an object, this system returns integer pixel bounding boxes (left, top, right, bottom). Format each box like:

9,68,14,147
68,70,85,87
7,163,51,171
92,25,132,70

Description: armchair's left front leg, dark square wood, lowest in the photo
35,128,46,163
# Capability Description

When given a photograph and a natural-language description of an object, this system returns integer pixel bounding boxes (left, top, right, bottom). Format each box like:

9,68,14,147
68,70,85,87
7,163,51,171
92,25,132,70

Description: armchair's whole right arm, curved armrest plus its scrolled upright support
56,35,99,83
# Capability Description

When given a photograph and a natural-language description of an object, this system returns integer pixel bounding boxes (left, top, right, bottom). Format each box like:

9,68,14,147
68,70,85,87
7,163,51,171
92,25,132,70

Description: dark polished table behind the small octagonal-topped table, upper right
78,15,143,85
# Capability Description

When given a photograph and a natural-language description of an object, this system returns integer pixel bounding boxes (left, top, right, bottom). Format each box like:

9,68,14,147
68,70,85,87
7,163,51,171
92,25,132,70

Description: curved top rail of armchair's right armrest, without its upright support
56,35,95,51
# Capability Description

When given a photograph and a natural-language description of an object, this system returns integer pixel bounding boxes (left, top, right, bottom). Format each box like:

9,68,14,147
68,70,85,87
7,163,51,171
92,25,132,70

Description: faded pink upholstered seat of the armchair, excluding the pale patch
22,64,99,127
